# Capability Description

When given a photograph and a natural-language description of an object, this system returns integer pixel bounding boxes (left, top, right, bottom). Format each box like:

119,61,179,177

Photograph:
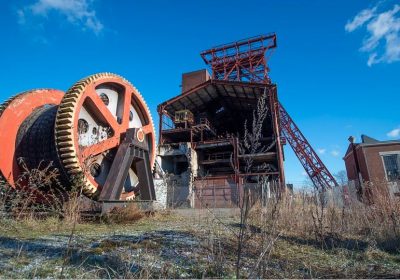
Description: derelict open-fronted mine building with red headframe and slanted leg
157,34,336,207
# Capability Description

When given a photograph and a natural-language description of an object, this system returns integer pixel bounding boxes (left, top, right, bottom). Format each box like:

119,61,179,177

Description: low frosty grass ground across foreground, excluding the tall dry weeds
0,209,400,278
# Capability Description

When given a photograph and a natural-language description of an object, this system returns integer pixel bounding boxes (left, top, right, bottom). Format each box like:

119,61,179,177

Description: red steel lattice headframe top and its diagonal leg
201,33,338,190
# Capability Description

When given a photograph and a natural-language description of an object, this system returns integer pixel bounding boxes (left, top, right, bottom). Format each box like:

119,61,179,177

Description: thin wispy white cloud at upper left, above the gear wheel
17,0,104,34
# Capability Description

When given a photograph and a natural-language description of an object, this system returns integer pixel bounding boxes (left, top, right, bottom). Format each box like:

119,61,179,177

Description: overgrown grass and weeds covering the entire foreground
0,173,400,278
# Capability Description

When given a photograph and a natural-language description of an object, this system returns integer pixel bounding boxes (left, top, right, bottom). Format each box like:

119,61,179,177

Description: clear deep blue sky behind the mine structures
0,0,400,184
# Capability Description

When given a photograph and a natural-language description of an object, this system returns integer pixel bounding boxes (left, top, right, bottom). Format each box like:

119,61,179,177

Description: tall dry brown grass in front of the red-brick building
250,180,400,252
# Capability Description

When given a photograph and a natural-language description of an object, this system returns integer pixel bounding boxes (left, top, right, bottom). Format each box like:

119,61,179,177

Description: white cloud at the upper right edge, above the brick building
345,4,400,66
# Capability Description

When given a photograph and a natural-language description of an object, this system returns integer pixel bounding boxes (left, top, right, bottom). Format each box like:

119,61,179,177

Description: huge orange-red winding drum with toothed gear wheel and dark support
0,73,156,203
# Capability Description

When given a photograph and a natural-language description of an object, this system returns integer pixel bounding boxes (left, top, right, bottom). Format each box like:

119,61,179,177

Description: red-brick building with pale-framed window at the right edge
343,135,400,184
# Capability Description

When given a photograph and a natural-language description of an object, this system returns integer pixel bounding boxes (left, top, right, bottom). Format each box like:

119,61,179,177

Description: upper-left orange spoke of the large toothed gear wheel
85,87,120,134
